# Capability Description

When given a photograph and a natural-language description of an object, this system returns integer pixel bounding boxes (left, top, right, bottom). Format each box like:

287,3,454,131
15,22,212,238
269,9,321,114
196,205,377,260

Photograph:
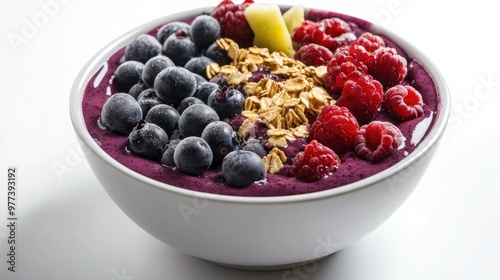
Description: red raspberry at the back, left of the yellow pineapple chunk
212,0,254,45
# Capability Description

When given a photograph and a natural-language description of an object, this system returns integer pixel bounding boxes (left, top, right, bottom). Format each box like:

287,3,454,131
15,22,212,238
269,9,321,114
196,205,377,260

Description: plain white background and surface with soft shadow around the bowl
0,0,500,280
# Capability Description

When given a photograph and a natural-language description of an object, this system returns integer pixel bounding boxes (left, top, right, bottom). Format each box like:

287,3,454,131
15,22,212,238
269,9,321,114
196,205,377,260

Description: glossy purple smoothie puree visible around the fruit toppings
82,10,439,196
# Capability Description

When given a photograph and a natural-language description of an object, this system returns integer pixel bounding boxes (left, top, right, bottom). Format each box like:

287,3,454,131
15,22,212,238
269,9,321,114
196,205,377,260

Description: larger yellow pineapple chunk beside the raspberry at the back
245,3,295,57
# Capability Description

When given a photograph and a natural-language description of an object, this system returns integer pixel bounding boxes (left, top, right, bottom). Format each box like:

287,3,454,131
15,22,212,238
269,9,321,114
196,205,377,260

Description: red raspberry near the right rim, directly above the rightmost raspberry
368,47,408,88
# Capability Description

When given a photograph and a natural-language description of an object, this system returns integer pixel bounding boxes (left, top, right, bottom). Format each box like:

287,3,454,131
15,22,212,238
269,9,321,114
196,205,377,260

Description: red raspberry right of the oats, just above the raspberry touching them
335,75,384,124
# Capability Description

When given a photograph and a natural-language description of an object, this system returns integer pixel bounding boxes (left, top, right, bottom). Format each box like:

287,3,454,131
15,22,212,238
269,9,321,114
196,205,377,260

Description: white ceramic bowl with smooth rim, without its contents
70,6,450,269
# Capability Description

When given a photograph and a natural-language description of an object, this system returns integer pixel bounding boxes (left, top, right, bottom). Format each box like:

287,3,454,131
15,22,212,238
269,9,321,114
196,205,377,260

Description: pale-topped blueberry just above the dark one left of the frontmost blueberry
179,104,219,137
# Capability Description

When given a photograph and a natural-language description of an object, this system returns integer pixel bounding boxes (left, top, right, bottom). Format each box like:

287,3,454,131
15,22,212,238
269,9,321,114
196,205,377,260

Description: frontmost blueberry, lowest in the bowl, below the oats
222,150,267,188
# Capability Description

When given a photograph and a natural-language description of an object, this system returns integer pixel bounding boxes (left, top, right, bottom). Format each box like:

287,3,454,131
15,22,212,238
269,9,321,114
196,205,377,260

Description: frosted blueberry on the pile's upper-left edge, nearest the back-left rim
125,34,162,63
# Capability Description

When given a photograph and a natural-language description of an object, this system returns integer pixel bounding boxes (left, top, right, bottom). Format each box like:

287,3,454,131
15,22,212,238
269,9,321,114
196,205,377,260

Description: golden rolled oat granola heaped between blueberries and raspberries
207,38,335,173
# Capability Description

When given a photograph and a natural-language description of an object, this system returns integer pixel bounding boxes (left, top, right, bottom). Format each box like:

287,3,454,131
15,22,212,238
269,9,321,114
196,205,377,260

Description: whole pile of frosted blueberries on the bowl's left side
100,15,266,187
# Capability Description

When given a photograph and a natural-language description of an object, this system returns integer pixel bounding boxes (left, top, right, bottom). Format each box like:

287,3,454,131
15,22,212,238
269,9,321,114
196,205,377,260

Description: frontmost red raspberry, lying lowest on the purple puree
290,140,340,182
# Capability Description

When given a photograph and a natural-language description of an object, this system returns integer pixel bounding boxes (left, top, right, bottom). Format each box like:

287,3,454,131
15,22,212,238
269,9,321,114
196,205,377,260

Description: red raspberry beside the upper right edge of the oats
323,46,368,93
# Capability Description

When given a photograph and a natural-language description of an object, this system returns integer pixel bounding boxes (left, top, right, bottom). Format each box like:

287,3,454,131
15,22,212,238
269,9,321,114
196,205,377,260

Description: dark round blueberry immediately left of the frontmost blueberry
174,136,213,176
